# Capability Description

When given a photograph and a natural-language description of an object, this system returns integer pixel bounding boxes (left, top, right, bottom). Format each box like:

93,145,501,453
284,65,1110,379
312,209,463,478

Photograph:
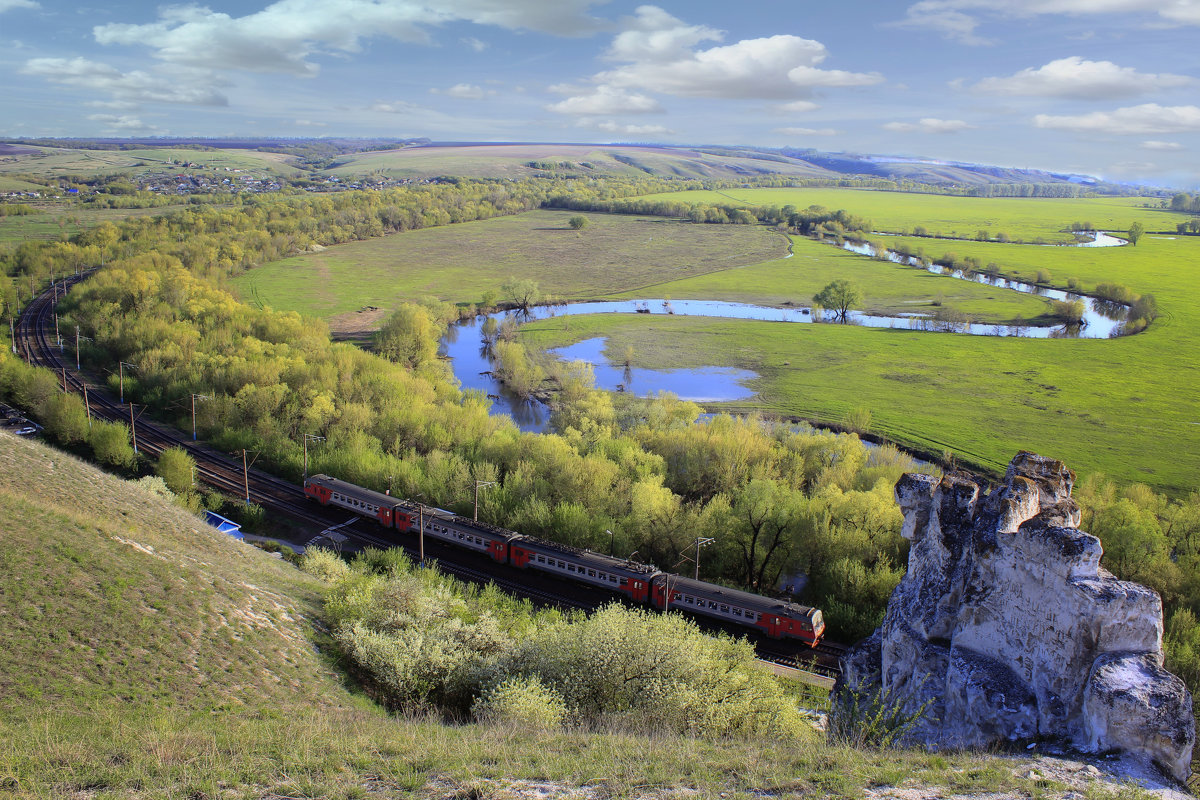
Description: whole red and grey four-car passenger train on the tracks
304,475,824,646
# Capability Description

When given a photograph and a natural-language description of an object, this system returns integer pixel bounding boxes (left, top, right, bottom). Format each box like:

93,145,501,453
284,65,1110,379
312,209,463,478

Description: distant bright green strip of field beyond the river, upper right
647,188,1183,246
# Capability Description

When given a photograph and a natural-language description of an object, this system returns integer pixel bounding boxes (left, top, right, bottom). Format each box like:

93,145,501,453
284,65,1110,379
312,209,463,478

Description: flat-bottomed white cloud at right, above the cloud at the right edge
974,55,1196,100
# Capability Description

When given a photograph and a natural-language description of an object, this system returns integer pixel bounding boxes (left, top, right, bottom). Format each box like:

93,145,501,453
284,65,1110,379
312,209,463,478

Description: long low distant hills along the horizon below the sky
0,138,1150,194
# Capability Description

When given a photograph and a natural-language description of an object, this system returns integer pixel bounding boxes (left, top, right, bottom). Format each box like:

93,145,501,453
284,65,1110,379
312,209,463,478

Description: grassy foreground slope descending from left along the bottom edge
0,433,1060,798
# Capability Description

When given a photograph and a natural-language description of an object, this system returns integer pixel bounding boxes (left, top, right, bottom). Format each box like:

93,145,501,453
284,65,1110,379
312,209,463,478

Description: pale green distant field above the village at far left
0,148,300,178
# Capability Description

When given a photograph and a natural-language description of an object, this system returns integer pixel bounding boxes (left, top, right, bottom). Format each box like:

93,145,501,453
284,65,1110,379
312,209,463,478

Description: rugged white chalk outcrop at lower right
838,452,1195,781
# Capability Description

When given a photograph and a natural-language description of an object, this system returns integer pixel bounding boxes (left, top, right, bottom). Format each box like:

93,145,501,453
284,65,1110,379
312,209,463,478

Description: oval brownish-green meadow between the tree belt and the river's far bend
236,211,787,317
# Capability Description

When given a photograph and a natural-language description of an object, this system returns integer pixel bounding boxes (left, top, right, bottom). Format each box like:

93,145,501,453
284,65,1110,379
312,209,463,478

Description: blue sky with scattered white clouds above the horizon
0,0,1200,188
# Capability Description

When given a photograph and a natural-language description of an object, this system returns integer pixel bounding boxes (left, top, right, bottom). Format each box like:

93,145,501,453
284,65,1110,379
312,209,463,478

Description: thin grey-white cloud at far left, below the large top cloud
20,58,229,108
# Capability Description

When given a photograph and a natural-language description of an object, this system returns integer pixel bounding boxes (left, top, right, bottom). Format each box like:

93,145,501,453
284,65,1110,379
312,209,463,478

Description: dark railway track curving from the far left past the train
14,272,846,676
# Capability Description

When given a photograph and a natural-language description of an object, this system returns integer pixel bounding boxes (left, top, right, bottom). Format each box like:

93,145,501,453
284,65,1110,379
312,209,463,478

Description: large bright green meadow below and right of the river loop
523,226,1200,494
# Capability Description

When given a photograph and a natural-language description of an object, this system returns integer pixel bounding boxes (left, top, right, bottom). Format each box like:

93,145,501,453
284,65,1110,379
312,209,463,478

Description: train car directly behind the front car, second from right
509,536,659,603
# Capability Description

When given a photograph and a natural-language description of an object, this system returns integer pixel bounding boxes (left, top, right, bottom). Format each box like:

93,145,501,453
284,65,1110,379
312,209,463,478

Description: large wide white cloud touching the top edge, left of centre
91,0,601,76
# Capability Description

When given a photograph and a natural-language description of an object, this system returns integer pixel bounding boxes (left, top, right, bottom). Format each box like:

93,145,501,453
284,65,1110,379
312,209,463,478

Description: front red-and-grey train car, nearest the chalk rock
650,572,824,646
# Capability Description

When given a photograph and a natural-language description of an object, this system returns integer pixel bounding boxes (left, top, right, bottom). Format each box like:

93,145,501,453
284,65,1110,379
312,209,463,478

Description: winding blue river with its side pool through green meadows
439,234,1127,431
